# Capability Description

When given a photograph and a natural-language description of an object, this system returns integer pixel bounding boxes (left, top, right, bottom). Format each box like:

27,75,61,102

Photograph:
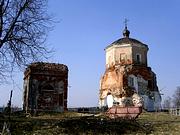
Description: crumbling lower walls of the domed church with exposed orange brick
99,65,159,108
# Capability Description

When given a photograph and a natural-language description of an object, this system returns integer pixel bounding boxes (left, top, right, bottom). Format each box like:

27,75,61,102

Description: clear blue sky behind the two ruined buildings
0,0,180,107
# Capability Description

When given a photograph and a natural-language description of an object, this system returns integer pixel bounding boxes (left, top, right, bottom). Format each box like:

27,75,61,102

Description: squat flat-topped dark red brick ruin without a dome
23,62,68,113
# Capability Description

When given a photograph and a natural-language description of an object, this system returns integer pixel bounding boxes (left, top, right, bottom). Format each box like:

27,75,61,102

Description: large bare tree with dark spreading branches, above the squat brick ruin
0,0,52,79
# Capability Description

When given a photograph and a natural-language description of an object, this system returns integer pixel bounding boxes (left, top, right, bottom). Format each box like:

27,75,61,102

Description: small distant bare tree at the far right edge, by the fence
173,86,180,108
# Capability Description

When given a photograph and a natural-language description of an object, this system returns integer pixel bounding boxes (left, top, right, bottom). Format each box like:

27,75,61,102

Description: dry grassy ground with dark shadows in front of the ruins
0,112,180,135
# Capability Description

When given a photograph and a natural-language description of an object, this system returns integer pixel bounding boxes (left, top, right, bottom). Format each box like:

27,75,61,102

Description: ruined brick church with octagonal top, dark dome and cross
99,25,161,111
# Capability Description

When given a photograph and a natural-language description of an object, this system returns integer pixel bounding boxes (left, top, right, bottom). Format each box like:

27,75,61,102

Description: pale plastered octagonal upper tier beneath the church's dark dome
106,44,148,68
